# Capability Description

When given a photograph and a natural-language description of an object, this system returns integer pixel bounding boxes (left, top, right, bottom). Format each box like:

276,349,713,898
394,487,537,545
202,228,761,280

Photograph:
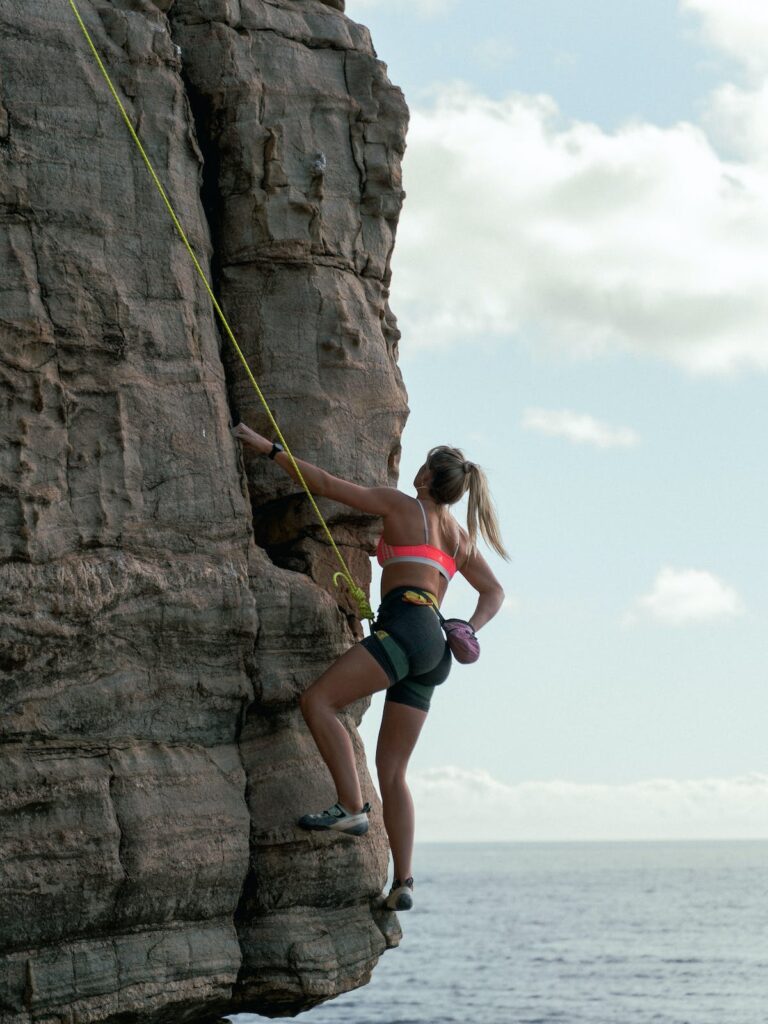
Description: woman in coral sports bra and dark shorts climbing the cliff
232,423,508,910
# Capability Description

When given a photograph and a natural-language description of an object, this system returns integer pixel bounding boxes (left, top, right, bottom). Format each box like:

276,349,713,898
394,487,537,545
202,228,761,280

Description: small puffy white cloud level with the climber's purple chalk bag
625,566,743,626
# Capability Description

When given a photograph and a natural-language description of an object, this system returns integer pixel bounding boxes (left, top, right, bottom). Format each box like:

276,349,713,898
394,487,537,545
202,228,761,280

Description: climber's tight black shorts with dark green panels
359,587,452,711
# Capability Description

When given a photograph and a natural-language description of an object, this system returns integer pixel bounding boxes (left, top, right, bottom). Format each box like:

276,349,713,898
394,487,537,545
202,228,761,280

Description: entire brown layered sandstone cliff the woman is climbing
0,0,408,1024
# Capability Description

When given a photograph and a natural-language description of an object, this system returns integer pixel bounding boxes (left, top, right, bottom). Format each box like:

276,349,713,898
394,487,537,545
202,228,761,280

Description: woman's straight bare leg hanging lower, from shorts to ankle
376,700,427,882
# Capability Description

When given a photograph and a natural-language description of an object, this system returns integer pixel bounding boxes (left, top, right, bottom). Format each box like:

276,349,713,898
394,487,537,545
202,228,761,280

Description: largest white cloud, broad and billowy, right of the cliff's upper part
392,82,768,372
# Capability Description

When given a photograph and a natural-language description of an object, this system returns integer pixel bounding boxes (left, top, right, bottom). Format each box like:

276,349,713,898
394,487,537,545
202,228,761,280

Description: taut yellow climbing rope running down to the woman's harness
70,0,374,622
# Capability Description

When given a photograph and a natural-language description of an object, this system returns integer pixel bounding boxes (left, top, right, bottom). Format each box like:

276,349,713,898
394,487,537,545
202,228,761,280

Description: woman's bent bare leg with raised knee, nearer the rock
300,645,389,814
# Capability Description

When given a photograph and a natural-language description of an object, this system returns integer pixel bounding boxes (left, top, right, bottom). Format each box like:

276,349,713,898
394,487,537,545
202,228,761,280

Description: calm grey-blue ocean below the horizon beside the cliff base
230,840,768,1024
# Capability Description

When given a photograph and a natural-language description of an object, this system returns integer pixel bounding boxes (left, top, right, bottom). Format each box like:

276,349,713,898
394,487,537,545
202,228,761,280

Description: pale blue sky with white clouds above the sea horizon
346,0,768,840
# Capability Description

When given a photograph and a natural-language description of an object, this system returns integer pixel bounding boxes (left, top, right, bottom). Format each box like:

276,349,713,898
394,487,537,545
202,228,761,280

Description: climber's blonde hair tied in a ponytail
425,444,509,560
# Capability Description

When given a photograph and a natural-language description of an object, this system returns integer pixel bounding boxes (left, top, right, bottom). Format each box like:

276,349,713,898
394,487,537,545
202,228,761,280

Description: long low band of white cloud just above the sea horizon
410,767,768,842
